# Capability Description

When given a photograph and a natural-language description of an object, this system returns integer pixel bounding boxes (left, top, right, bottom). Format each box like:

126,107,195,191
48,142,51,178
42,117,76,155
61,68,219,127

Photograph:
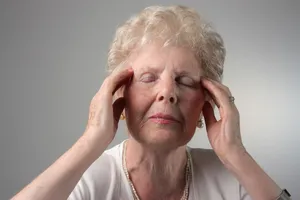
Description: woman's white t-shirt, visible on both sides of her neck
68,141,251,200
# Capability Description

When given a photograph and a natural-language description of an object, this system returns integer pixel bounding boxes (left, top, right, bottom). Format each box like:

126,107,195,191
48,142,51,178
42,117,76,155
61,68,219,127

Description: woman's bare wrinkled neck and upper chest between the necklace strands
125,138,187,200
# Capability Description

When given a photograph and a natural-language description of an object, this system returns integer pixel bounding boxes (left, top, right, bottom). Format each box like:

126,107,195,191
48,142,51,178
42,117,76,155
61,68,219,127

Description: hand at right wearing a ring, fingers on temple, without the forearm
201,77,245,161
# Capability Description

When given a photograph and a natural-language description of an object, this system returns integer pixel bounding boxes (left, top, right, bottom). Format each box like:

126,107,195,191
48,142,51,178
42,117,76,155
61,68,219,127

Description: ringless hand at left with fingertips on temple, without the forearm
84,67,133,148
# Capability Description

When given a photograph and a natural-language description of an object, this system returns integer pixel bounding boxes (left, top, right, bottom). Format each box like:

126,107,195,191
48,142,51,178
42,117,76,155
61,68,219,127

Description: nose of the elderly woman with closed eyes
157,78,178,104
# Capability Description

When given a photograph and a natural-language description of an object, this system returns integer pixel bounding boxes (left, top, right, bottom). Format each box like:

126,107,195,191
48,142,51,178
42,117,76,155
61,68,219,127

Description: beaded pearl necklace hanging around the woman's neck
122,140,192,200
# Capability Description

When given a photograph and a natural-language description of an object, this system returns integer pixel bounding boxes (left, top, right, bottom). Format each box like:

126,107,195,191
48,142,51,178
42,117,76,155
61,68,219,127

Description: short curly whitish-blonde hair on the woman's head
108,5,226,82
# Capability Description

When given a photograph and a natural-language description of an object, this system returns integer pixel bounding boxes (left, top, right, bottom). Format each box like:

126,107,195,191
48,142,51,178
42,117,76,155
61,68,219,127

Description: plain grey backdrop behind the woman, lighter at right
0,0,300,199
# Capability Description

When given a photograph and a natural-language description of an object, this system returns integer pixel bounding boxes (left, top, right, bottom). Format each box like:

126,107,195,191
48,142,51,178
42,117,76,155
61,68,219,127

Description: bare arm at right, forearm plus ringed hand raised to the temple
201,77,288,200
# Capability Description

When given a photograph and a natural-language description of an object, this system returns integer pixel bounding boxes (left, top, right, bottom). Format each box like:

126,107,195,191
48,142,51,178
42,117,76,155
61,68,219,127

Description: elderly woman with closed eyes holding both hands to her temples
13,6,290,200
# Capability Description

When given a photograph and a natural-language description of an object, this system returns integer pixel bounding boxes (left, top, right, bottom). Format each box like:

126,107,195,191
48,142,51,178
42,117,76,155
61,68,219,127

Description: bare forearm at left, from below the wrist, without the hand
12,136,106,200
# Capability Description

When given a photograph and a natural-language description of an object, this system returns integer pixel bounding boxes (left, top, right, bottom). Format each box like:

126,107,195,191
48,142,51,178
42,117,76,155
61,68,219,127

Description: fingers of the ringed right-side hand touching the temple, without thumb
201,78,235,114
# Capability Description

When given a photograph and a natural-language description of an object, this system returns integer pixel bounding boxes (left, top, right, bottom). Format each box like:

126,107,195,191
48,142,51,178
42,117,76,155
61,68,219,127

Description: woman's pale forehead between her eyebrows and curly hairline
130,43,202,74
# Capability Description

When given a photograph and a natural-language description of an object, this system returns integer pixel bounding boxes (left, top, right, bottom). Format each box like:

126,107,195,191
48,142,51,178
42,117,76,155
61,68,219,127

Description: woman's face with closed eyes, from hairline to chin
124,44,204,147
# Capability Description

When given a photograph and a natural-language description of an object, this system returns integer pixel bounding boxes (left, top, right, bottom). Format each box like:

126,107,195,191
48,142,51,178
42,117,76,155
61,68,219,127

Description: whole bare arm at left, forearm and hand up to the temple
12,68,133,200
